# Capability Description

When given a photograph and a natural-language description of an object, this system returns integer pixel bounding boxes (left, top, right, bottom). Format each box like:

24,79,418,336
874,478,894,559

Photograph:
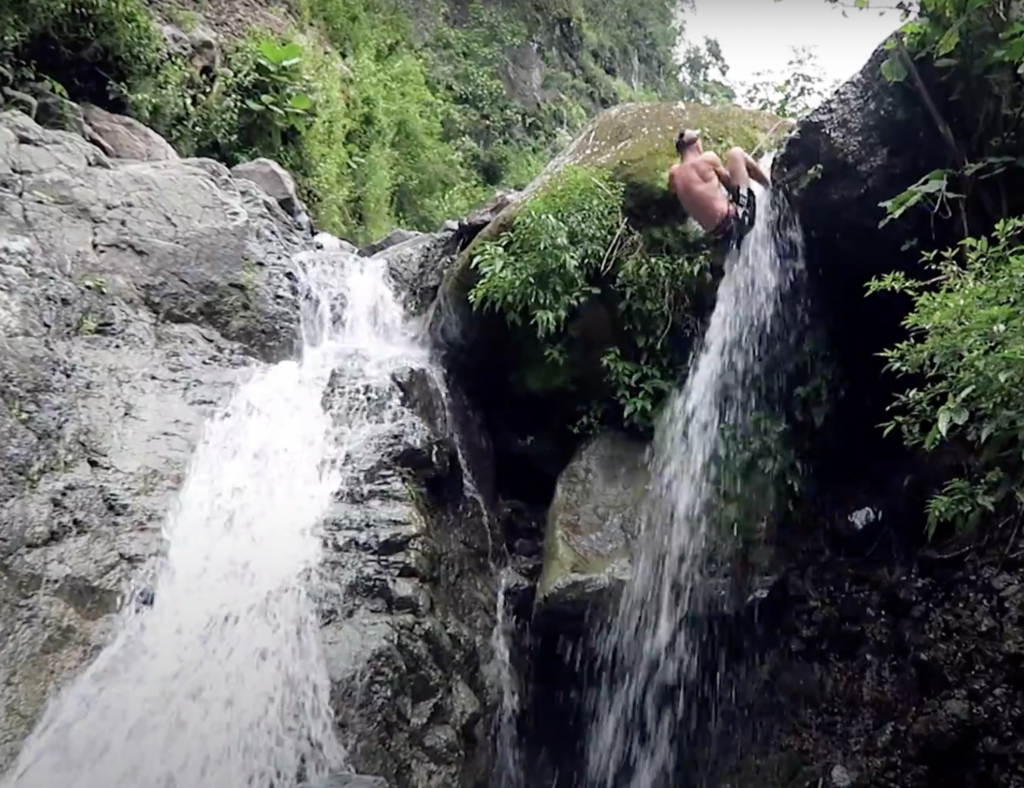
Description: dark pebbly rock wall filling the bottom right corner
712,542,1024,788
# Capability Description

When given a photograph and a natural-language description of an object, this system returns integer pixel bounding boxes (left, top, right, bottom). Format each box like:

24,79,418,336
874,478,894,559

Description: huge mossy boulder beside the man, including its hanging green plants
429,103,787,502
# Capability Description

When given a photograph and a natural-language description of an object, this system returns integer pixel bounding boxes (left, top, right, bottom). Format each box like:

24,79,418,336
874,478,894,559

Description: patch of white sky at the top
684,0,900,88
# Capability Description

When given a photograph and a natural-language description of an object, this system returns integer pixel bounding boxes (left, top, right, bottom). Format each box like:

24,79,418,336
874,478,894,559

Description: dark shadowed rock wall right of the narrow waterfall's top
772,47,949,483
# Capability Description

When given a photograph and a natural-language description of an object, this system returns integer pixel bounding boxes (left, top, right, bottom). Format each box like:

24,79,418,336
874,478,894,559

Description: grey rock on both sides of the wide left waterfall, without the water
0,112,496,786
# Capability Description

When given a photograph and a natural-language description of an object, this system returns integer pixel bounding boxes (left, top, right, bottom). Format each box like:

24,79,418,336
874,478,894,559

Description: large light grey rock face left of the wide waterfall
0,113,303,771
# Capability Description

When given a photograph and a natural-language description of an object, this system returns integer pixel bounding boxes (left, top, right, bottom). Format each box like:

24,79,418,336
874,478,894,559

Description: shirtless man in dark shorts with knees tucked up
669,129,770,249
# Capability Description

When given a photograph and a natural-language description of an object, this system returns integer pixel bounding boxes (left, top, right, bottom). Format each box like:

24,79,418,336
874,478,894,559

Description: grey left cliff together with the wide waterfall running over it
0,113,497,788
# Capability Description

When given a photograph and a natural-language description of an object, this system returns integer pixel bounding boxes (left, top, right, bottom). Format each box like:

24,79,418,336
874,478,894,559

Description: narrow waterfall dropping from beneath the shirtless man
588,162,803,788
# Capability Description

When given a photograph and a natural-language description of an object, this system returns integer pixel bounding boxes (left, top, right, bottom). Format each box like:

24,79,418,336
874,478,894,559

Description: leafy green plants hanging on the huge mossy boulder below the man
470,167,710,430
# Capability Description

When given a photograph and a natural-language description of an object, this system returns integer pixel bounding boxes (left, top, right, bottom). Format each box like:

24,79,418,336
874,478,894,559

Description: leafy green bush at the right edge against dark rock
868,218,1024,533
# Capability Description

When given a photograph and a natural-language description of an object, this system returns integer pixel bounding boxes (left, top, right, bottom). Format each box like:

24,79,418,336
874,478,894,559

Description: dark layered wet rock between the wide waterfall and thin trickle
323,367,496,788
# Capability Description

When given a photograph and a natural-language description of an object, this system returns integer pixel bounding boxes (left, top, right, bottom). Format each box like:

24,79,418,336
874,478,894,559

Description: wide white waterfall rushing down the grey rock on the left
0,238,423,788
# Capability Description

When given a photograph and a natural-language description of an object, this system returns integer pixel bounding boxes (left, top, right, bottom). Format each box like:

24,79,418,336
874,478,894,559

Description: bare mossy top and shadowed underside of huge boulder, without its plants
427,103,787,505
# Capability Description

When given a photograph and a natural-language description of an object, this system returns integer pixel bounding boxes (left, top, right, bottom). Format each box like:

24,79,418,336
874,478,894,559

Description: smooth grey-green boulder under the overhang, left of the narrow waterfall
538,433,648,615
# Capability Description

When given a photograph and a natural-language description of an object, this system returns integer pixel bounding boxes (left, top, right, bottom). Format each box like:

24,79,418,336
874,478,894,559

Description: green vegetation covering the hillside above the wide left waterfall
6,0,688,240
